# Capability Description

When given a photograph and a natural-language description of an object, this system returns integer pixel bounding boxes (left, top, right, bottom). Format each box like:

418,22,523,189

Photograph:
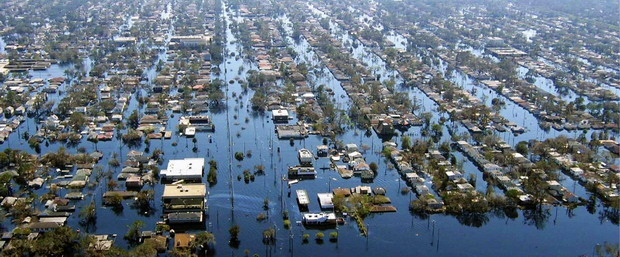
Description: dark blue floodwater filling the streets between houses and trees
0,1,618,256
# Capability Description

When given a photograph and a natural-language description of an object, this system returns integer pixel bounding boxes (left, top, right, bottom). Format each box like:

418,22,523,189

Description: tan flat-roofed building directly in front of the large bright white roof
162,183,207,224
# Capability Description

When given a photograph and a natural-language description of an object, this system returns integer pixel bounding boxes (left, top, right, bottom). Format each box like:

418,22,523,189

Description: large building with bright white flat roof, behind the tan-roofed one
160,158,205,181
